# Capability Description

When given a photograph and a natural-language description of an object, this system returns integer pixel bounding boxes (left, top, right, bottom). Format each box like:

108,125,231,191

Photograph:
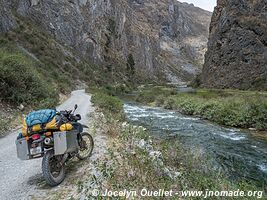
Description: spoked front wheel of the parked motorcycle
77,132,94,160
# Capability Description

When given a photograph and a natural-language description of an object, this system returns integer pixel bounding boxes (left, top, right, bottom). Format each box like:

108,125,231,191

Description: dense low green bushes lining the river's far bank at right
172,95,267,130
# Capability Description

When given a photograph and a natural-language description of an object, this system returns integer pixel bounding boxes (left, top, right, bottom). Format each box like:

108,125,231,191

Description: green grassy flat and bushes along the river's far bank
136,87,267,130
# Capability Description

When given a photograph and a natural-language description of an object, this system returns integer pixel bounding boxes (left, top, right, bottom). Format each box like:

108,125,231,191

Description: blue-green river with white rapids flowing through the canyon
124,103,267,185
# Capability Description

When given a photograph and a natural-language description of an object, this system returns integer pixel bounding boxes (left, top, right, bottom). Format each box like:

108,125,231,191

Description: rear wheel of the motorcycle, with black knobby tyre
42,151,66,186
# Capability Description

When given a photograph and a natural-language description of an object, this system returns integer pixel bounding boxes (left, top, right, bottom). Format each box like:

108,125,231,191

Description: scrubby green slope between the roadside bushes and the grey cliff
0,15,144,104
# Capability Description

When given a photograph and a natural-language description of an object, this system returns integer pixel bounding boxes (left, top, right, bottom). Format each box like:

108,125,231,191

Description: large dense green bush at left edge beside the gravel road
0,50,58,107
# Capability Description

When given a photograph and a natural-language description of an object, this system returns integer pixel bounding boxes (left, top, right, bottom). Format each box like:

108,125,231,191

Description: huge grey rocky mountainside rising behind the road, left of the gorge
0,0,211,82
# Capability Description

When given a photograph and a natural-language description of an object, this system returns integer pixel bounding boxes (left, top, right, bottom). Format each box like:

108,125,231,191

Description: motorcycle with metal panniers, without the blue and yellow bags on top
16,105,94,186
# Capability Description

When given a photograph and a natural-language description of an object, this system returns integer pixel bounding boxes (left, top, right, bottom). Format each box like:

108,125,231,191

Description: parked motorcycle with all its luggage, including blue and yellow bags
16,105,94,186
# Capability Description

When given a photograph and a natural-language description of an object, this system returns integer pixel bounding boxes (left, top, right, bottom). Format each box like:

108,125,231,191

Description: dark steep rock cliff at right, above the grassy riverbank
202,0,267,90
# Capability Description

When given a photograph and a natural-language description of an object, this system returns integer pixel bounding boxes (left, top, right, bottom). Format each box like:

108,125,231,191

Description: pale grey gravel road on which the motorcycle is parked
0,90,93,200
